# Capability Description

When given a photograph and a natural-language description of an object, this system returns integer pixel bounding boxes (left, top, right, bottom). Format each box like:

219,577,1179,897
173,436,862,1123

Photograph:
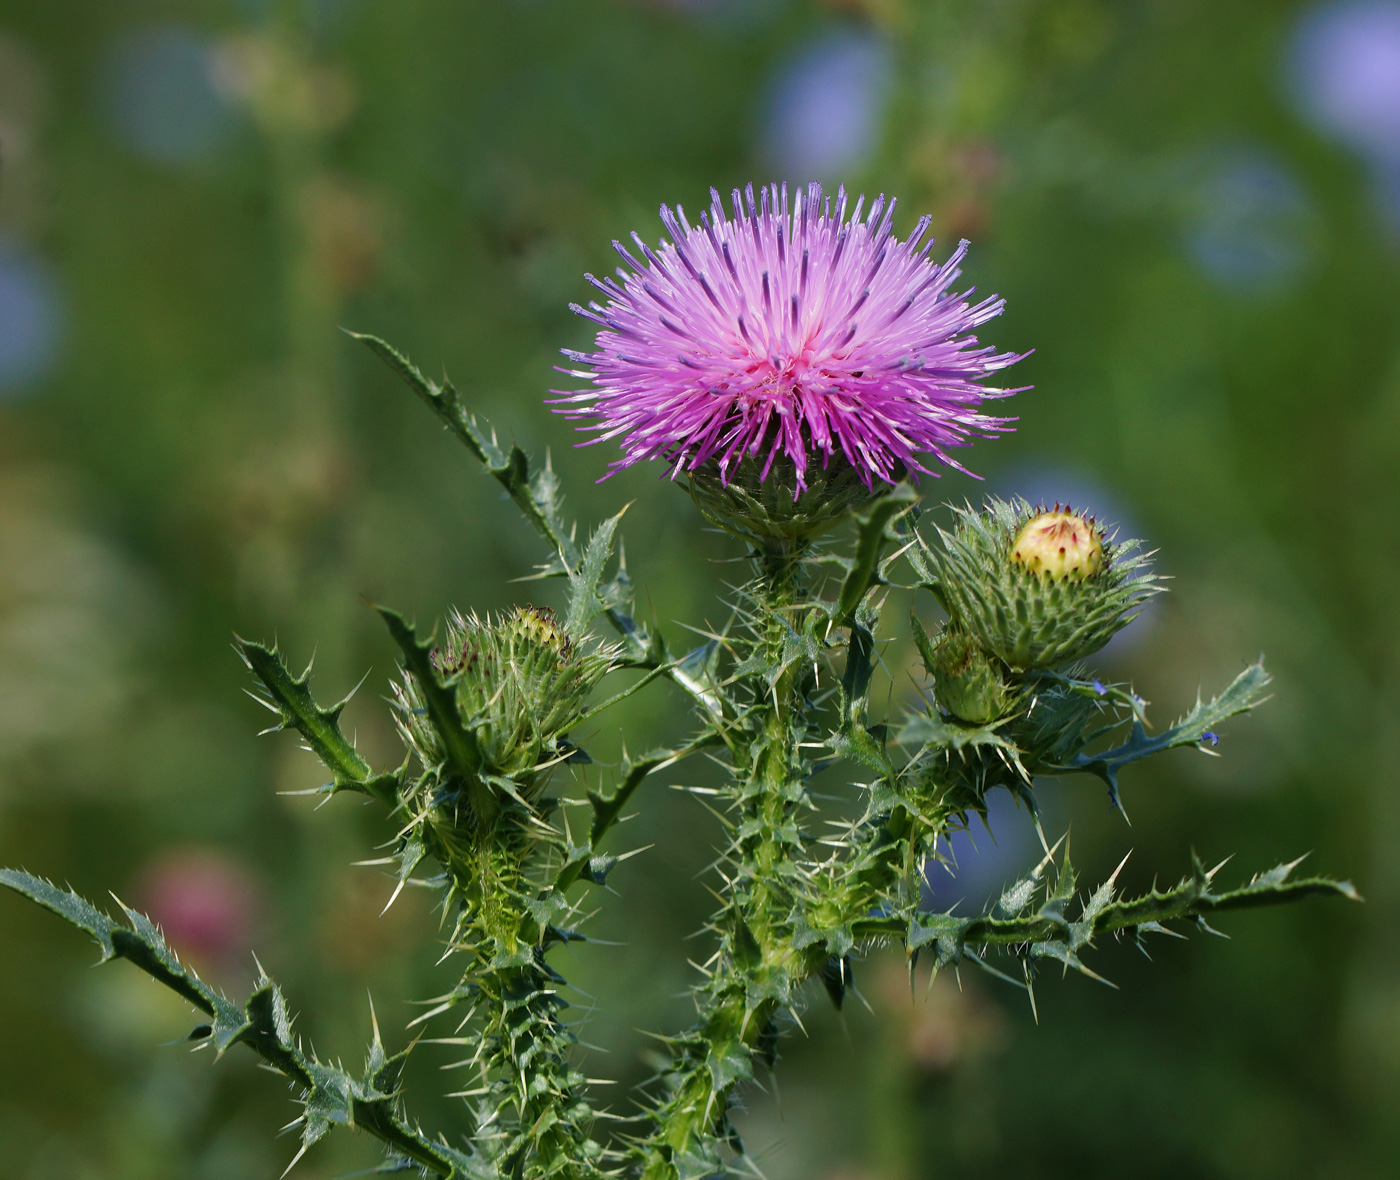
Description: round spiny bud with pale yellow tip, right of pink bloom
928,498,1161,672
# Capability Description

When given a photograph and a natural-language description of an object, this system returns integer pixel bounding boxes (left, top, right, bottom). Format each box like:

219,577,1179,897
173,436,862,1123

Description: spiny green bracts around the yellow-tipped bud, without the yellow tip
921,497,1162,672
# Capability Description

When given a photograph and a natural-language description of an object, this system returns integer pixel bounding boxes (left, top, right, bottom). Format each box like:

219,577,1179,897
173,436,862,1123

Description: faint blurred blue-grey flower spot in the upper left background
98,25,237,164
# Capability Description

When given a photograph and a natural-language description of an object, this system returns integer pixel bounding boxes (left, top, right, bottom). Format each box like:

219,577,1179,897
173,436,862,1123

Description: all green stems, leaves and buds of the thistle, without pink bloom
0,331,1357,1180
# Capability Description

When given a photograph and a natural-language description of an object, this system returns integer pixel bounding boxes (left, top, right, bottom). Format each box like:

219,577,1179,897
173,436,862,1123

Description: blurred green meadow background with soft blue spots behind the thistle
0,0,1400,1180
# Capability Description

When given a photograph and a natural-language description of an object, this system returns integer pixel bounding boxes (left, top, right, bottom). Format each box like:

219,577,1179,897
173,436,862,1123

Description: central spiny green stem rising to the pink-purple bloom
644,545,813,1180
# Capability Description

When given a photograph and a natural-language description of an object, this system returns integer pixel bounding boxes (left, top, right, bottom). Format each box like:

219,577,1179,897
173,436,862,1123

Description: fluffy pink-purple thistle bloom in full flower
556,185,1021,491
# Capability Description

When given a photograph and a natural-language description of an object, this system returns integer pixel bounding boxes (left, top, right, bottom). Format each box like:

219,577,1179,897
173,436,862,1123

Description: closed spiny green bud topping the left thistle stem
395,606,617,794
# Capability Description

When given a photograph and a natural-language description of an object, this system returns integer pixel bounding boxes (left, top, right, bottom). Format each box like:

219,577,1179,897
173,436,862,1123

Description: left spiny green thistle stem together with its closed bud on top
391,607,610,1177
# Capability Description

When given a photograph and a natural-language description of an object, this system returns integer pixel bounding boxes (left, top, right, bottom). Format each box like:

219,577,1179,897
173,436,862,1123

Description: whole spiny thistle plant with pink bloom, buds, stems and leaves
0,186,1355,1180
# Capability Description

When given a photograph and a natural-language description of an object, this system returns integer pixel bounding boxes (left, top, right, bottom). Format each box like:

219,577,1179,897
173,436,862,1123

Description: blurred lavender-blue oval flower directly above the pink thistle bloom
759,28,893,183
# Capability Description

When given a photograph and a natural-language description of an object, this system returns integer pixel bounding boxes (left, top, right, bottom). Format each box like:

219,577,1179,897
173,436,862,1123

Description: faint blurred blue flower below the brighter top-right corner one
1184,148,1315,294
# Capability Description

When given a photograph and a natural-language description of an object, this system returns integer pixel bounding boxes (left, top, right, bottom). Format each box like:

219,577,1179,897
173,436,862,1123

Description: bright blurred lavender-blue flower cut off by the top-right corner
1288,0,1400,160
